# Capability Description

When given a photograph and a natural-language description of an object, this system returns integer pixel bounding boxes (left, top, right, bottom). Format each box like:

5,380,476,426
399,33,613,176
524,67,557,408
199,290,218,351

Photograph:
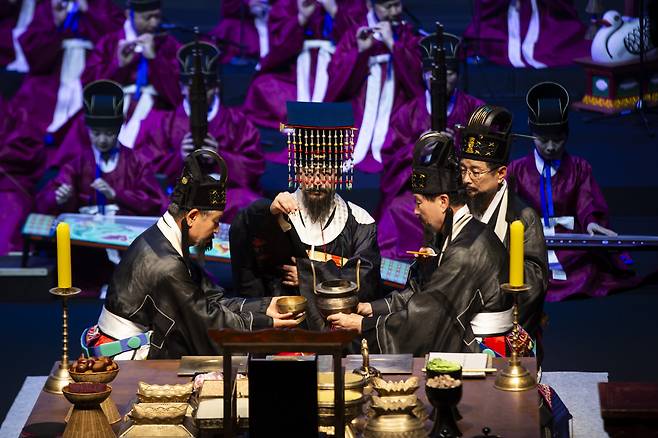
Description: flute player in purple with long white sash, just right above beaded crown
326,0,423,172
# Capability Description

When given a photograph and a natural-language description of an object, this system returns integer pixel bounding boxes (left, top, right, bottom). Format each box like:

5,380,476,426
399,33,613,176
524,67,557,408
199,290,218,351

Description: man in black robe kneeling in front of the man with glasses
328,131,512,356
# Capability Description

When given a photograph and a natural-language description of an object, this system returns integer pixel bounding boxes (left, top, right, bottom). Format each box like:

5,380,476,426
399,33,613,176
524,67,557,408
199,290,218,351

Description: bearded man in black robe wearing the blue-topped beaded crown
230,102,381,301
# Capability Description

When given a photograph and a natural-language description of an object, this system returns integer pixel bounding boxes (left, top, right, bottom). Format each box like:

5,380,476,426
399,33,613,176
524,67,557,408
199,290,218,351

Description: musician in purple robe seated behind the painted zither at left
36,81,167,216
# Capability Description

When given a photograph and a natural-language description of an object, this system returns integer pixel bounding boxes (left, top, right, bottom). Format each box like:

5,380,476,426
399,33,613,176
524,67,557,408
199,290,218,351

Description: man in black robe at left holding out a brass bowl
83,149,296,359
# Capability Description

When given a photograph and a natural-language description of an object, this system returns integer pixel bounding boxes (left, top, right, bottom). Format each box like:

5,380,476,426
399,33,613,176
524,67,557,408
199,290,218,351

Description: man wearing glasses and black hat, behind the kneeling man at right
460,105,548,358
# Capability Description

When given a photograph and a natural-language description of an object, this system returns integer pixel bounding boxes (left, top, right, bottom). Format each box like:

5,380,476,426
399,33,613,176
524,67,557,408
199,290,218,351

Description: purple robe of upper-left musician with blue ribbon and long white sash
4,0,124,144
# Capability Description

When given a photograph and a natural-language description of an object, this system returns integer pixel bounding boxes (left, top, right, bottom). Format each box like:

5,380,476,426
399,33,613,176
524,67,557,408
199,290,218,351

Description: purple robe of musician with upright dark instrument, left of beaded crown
135,105,265,223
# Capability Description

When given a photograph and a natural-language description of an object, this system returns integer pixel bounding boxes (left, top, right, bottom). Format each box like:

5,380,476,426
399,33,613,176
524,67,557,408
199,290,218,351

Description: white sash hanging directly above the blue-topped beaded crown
297,40,336,102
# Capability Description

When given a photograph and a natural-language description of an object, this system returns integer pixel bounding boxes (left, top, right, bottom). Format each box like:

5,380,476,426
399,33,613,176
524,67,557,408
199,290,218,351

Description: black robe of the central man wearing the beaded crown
229,199,381,301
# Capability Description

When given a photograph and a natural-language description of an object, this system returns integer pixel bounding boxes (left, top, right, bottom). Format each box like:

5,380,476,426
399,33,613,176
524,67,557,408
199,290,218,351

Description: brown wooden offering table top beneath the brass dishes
21,358,540,438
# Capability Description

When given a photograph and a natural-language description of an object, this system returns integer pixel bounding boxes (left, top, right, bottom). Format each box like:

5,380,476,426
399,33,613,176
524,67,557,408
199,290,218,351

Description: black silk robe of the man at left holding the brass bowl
105,225,272,359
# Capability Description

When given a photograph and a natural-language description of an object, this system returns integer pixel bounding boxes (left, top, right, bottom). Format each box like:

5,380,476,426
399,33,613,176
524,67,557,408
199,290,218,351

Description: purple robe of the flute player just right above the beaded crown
326,18,424,172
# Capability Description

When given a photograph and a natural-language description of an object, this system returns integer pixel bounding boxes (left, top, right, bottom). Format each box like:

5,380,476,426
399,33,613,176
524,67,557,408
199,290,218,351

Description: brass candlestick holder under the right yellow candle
494,283,537,391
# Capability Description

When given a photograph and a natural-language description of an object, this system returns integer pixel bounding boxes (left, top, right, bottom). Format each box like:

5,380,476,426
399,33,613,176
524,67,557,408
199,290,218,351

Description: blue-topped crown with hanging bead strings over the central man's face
281,102,356,190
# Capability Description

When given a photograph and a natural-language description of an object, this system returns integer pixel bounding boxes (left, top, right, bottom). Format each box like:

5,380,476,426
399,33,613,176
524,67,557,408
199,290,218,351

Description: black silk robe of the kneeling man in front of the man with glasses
362,218,511,356
